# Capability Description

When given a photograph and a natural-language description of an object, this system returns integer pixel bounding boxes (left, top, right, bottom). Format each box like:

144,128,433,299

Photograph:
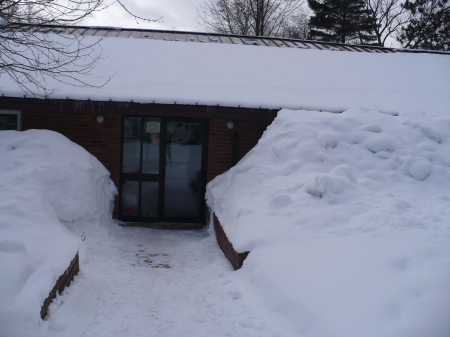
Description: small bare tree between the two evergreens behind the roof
367,0,408,46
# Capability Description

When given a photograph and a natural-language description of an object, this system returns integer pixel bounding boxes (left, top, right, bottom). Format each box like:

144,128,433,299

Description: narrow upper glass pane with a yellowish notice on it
142,118,161,174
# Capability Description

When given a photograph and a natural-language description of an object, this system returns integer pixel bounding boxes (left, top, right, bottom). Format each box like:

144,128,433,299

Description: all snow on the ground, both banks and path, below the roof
0,109,450,337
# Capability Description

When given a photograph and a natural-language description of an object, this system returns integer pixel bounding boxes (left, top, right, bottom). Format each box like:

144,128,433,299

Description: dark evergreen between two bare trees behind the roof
308,0,376,44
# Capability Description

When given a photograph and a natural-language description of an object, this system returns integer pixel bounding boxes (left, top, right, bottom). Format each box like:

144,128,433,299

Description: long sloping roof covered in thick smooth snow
0,27,450,112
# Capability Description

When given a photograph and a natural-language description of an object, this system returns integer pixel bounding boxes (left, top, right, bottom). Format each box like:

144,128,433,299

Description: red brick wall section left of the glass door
22,111,122,218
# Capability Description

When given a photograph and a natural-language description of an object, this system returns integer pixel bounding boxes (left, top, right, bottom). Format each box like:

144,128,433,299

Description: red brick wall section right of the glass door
207,119,271,182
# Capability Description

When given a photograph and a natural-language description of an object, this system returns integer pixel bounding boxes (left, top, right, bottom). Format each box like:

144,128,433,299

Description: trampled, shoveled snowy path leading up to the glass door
47,226,279,337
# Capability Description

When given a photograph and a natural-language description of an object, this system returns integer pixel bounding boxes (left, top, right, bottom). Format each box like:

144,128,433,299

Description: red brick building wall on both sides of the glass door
22,110,271,218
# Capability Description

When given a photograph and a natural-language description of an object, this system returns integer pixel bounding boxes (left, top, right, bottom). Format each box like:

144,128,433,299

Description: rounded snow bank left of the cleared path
0,130,116,337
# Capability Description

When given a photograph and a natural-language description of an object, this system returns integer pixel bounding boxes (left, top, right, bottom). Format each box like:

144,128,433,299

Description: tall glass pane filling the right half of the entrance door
164,122,203,218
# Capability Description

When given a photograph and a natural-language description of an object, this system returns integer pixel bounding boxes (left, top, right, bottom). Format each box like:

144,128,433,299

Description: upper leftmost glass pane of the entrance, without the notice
123,117,141,173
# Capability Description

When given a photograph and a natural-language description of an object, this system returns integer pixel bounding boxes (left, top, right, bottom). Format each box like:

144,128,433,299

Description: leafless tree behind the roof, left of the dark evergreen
197,0,303,37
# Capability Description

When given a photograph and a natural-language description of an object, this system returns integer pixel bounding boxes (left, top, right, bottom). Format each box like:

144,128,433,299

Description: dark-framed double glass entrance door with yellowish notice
120,117,207,223
